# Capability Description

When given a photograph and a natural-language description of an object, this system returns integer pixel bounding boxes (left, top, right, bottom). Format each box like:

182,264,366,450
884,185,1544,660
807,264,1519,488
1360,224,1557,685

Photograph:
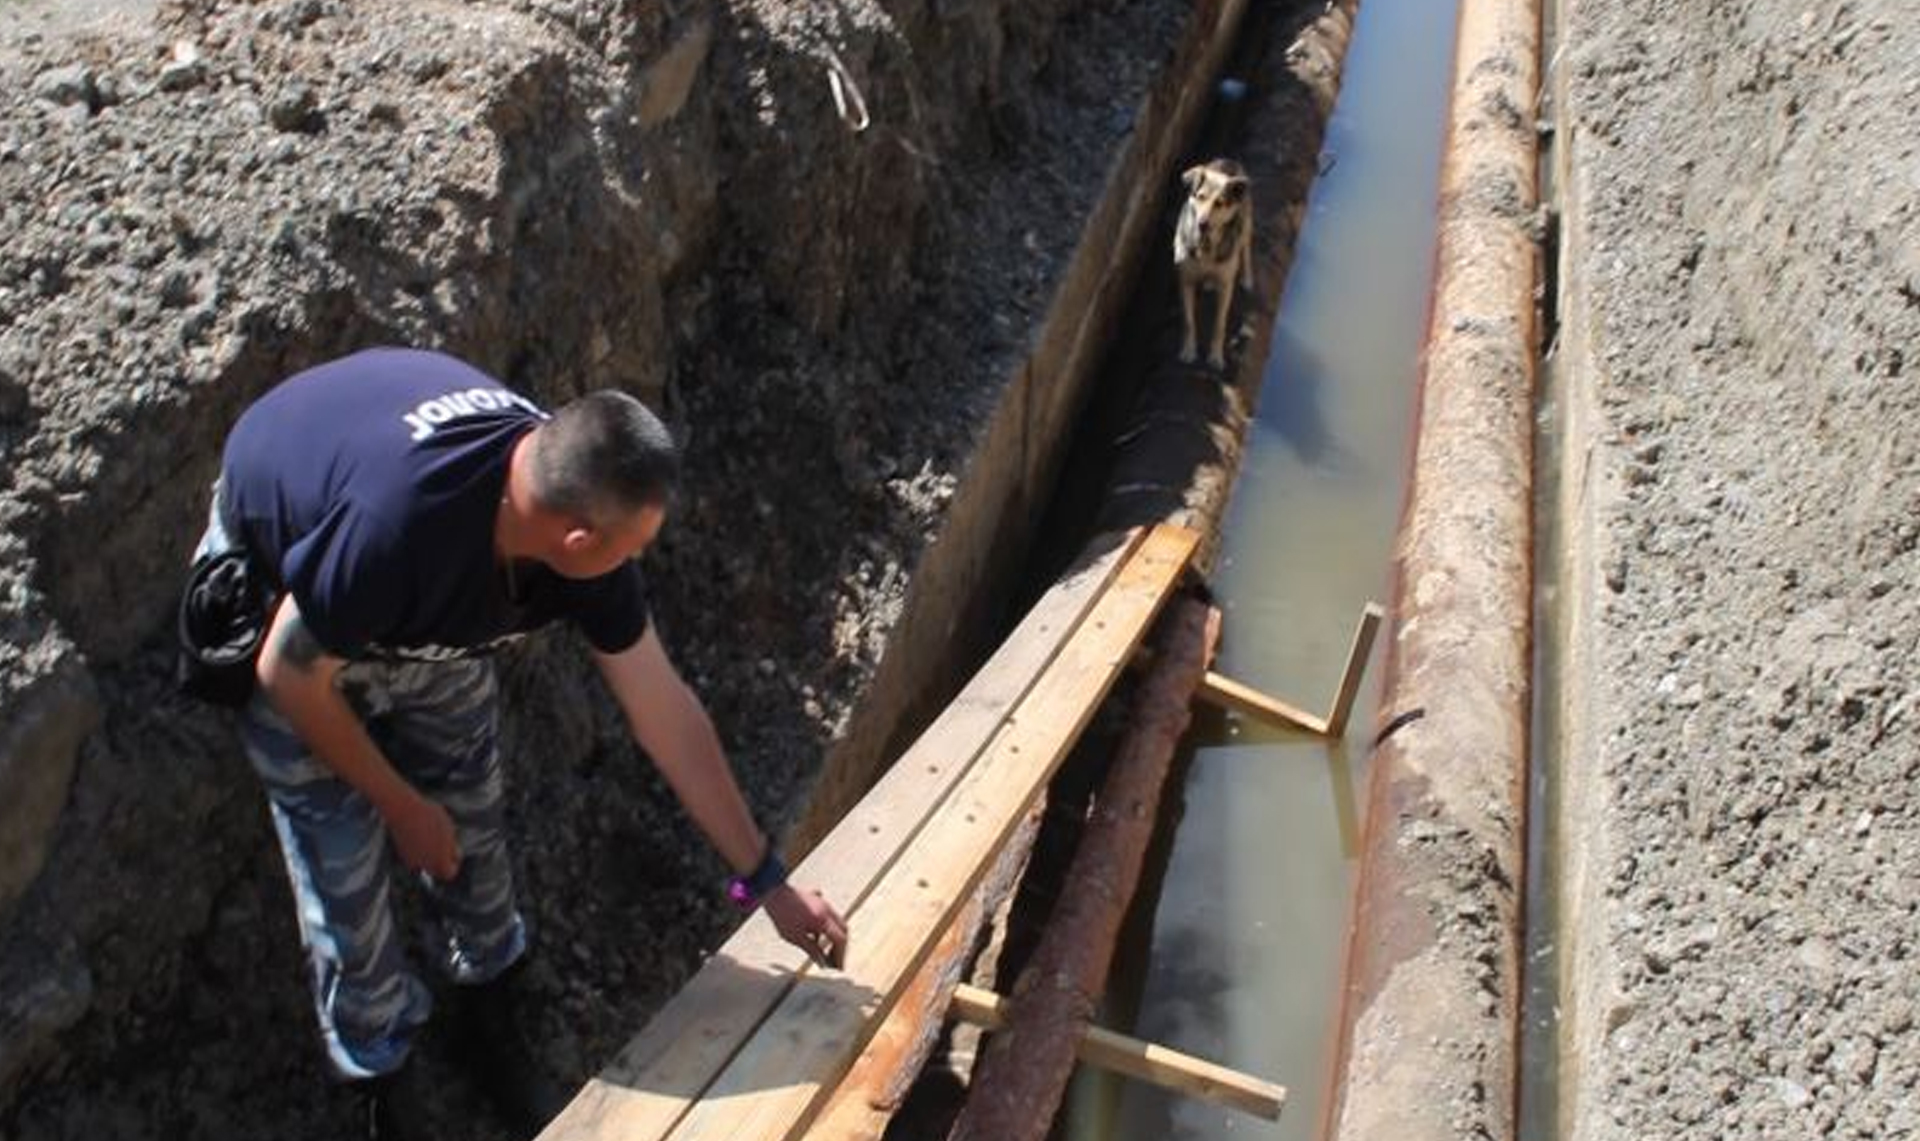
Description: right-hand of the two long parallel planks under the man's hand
660,524,1198,1141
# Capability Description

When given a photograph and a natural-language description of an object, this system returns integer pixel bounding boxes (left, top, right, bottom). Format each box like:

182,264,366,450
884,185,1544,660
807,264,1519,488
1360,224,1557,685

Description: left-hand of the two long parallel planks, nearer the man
540,530,1146,1141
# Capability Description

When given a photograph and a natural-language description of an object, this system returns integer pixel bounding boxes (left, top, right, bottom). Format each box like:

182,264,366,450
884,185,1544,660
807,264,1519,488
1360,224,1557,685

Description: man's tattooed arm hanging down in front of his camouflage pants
255,594,461,880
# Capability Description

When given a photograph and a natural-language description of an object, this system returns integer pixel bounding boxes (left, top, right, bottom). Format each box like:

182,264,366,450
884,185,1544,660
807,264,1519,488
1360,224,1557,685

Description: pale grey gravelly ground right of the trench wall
1557,0,1920,1141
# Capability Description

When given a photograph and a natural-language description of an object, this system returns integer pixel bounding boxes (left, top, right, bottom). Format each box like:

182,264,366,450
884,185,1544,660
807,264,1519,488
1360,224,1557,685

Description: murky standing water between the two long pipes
1064,0,1453,1141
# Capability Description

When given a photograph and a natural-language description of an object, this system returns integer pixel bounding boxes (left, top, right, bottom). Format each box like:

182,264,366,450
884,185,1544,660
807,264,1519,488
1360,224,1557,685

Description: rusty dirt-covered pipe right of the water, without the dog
1325,0,1540,1141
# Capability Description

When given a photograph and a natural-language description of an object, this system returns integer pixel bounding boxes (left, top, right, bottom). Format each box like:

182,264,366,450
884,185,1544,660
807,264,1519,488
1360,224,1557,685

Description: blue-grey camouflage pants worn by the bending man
202,485,526,1080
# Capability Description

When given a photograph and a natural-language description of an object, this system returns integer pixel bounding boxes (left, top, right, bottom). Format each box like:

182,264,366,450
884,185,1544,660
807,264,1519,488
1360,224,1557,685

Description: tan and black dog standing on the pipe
1173,159,1254,369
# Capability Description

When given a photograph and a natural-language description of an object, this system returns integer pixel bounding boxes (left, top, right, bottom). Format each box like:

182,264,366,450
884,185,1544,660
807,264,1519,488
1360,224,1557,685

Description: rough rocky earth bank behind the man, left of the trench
0,0,1187,1141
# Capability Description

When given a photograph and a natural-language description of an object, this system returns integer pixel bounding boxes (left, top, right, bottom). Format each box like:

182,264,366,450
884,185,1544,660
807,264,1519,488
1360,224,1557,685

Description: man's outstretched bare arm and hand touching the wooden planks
595,626,847,966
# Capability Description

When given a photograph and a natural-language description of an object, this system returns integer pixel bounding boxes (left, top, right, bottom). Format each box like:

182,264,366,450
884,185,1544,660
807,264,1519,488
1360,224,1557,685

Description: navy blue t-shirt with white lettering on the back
221,350,647,661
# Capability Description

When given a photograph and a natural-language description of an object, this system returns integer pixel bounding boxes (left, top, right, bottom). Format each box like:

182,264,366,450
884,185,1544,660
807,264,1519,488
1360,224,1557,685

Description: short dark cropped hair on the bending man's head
532,390,680,524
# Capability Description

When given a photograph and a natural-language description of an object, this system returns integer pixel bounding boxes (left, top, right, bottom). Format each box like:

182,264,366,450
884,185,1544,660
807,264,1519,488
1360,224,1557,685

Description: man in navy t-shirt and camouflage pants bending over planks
200,350,847,1137
